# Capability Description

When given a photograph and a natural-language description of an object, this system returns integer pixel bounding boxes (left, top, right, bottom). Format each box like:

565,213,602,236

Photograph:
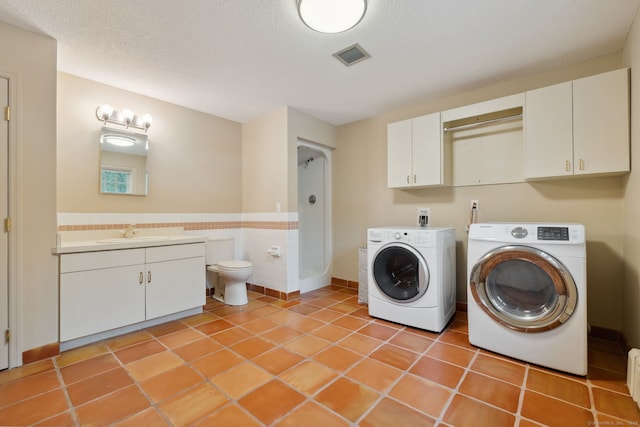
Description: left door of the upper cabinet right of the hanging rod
524,82,573,179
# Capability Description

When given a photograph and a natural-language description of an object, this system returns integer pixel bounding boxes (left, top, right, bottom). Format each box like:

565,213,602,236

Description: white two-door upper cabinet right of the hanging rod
525,68,630,179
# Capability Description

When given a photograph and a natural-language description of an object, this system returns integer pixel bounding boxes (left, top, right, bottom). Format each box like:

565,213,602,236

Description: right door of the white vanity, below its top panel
146,257,206,319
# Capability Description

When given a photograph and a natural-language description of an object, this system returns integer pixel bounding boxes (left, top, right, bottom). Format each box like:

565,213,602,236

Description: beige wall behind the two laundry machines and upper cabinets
332,55,624,330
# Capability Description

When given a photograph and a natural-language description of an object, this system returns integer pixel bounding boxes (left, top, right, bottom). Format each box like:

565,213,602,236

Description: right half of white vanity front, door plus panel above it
146,243,206,319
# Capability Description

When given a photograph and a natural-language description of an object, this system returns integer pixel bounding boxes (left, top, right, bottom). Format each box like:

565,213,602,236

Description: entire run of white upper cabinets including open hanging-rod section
387,68,630,189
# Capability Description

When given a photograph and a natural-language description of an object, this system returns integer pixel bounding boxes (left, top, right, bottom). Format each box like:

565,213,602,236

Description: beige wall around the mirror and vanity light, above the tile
58,73,242,213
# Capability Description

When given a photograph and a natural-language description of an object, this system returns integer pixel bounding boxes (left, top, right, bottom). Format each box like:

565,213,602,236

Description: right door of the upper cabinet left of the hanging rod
412,113,444,186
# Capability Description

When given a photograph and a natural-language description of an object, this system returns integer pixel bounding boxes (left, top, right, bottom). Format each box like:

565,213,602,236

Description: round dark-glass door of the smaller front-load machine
371,243,429,303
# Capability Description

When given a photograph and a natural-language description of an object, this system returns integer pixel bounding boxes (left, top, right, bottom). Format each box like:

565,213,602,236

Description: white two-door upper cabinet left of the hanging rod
387,113,445,188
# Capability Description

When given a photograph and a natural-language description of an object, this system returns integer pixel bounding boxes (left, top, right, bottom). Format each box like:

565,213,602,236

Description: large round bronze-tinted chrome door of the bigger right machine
469,246,578,332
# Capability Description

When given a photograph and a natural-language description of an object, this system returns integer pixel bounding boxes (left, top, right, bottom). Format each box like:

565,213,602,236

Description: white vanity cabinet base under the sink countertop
60,243,206,342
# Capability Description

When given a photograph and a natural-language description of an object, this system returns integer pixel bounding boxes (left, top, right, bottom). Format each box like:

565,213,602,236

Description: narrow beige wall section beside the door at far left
0,22,58,358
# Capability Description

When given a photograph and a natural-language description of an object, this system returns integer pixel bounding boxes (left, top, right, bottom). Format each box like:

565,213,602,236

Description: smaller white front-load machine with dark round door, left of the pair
367,227,456,332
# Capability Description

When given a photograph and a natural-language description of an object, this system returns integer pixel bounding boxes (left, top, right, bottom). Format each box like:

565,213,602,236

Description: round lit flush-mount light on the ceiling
298,0,367,33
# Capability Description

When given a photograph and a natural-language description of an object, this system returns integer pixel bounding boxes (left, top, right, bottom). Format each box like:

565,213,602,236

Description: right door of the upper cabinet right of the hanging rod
573,68,629,175
